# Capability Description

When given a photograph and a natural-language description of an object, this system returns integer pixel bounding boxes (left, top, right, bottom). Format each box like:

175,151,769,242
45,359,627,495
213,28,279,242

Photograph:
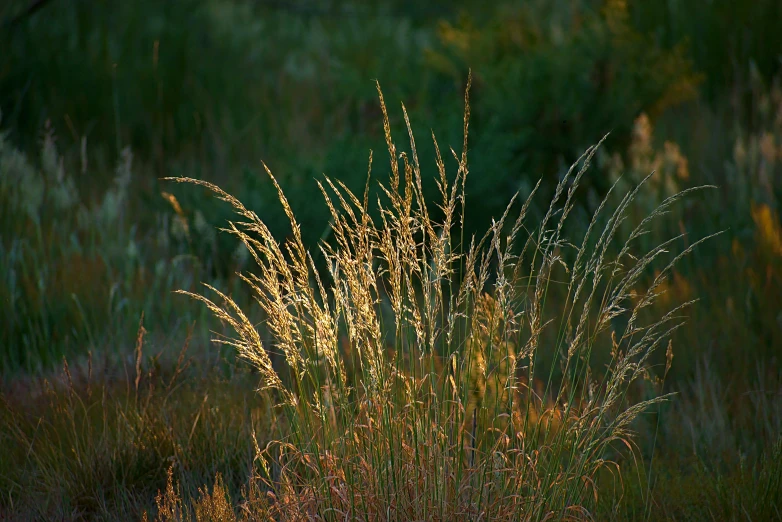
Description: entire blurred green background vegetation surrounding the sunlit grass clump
0,0,782,516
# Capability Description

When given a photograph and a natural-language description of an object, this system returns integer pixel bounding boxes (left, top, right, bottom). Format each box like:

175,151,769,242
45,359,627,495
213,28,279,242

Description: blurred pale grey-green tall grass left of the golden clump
0,119,245,372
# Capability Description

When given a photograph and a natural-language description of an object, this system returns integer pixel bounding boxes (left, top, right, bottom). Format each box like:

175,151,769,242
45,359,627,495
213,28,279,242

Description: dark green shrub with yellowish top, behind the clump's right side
427,0,701,234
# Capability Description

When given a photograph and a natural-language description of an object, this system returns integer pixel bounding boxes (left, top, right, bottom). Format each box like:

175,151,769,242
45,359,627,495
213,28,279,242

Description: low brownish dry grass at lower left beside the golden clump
0,320,273,521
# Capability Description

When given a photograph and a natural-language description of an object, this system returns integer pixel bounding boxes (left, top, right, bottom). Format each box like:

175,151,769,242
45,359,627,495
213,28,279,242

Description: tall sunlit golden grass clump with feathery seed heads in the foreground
161,78,716,520
